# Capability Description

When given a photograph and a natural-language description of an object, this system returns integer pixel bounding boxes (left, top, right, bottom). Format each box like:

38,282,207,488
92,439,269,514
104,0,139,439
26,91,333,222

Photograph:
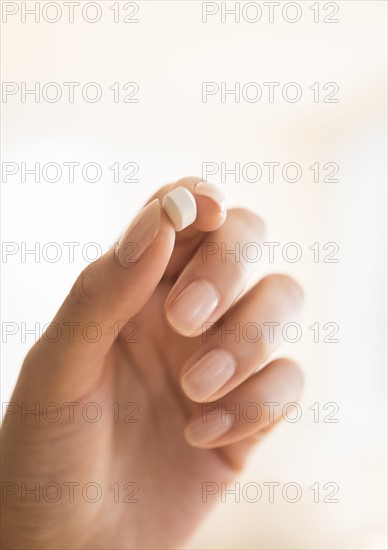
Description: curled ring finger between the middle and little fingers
180,275,303,402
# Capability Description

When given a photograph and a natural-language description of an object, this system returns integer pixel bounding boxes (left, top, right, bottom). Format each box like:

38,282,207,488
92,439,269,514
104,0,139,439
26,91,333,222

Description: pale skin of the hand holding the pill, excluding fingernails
1,178,303,549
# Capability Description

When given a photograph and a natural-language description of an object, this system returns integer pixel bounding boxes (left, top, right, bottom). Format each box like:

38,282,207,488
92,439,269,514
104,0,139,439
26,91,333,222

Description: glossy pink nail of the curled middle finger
166,279,219,336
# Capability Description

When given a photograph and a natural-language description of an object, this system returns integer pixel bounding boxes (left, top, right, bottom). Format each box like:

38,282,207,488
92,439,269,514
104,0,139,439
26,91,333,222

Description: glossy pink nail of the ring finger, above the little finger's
181,349,236,401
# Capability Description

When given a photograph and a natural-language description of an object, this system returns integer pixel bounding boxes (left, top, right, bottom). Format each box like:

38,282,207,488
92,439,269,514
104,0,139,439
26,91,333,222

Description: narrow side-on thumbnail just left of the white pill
117,199,160,267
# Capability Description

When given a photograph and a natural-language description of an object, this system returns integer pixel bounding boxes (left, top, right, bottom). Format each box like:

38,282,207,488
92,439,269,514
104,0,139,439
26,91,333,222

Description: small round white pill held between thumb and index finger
163,187,197,231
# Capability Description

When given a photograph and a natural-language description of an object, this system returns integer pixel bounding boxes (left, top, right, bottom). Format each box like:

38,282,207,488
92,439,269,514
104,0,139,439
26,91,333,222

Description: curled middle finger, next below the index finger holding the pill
165,209,264,337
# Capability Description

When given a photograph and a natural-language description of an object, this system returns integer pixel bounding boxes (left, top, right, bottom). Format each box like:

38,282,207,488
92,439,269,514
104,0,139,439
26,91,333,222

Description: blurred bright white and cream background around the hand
1,0,387,549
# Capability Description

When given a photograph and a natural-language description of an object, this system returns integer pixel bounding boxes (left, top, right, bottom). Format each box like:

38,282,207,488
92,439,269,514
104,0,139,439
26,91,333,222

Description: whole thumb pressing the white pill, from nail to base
18,199,175,398
